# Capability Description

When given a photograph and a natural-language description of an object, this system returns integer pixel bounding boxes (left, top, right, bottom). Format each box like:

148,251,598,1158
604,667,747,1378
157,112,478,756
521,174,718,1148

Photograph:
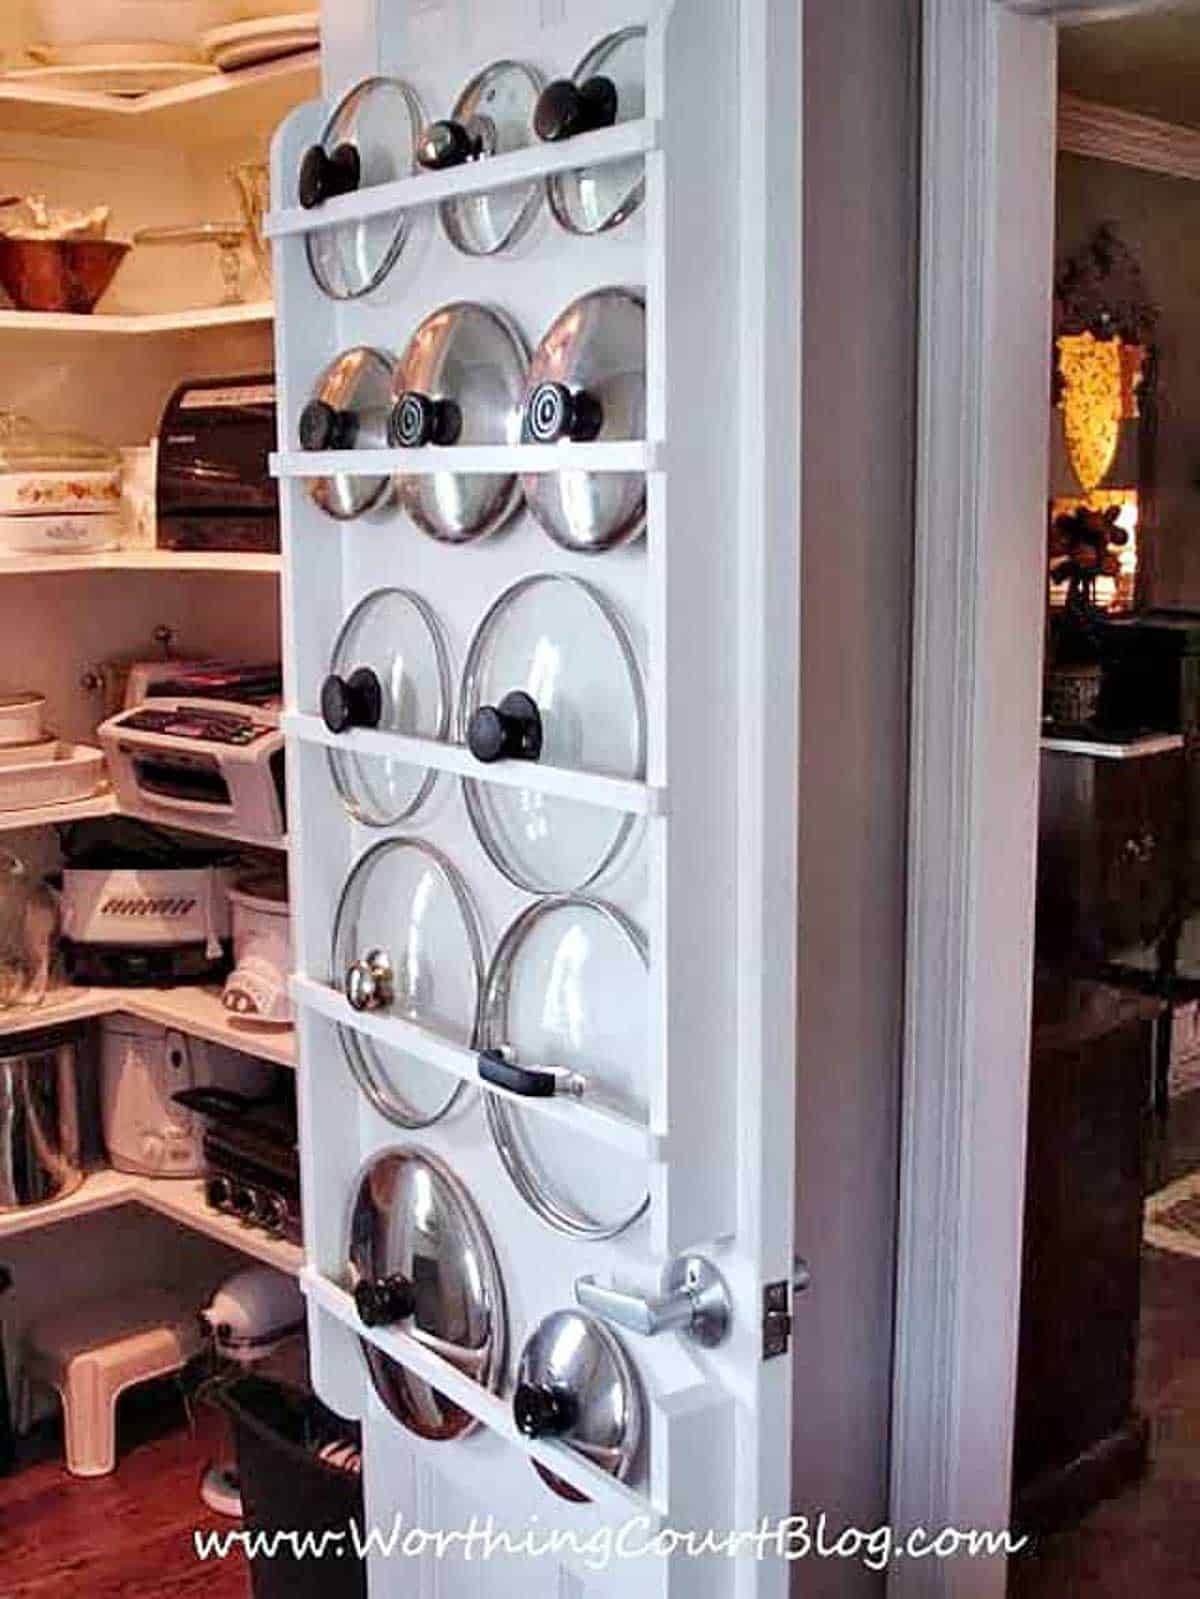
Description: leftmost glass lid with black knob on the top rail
298,78,424,299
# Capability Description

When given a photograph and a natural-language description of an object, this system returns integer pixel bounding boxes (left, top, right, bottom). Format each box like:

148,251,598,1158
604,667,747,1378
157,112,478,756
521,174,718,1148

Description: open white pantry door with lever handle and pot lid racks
280,0,800,1599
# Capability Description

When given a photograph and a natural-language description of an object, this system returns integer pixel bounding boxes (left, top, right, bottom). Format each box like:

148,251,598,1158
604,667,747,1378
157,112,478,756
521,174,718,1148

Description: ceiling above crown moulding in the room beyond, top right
1059,0,1200,128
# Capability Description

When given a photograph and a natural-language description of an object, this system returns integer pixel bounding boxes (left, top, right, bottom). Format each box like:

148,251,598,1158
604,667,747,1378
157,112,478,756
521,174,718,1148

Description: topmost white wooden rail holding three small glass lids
266,117,659,238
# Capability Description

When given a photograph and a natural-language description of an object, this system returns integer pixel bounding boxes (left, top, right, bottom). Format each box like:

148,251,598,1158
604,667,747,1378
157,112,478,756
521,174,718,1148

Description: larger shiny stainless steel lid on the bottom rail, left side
349,1150,507,1439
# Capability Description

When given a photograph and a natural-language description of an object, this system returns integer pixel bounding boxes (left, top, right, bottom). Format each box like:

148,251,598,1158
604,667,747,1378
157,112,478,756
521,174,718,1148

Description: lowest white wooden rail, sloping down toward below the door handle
299,1265,662,1537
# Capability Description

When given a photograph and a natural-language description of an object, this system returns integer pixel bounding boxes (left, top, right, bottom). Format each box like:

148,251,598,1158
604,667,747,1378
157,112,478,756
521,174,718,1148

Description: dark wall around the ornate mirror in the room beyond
1056,155,1200,608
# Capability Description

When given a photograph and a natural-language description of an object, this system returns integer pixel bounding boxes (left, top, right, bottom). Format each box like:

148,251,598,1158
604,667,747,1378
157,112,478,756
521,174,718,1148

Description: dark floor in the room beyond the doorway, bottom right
1008,1094,1200,1599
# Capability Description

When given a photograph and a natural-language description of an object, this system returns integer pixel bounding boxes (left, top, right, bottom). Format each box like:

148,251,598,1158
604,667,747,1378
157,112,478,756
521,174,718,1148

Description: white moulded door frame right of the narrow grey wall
888,0,1163,1599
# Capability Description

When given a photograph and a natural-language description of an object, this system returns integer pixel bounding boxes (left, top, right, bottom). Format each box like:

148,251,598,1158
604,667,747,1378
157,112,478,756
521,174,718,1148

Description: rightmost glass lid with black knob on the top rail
534,27,646,233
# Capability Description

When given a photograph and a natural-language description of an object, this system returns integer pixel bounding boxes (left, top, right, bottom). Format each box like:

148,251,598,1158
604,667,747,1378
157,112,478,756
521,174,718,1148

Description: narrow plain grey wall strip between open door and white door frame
794,0,920,1599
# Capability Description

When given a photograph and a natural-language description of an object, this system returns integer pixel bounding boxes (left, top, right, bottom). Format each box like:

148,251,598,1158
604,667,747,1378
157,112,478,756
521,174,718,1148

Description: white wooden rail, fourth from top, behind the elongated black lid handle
291,975,666,1161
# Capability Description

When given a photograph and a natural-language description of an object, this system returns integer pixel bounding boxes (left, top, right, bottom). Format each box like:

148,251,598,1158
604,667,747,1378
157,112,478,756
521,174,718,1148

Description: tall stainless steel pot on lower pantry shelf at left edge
0,1028,83,1212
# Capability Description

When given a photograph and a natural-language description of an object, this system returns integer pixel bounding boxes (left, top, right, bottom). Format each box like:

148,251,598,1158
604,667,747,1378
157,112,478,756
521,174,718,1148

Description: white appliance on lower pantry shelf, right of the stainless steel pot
101,1015,275,1177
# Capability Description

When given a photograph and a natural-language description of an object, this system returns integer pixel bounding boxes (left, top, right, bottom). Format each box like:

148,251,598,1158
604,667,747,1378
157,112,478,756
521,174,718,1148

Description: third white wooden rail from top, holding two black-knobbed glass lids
283,712,667,817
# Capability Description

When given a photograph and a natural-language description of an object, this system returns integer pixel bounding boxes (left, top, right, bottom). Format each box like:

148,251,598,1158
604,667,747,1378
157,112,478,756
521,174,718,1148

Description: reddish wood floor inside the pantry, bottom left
0,1398,250,1599
